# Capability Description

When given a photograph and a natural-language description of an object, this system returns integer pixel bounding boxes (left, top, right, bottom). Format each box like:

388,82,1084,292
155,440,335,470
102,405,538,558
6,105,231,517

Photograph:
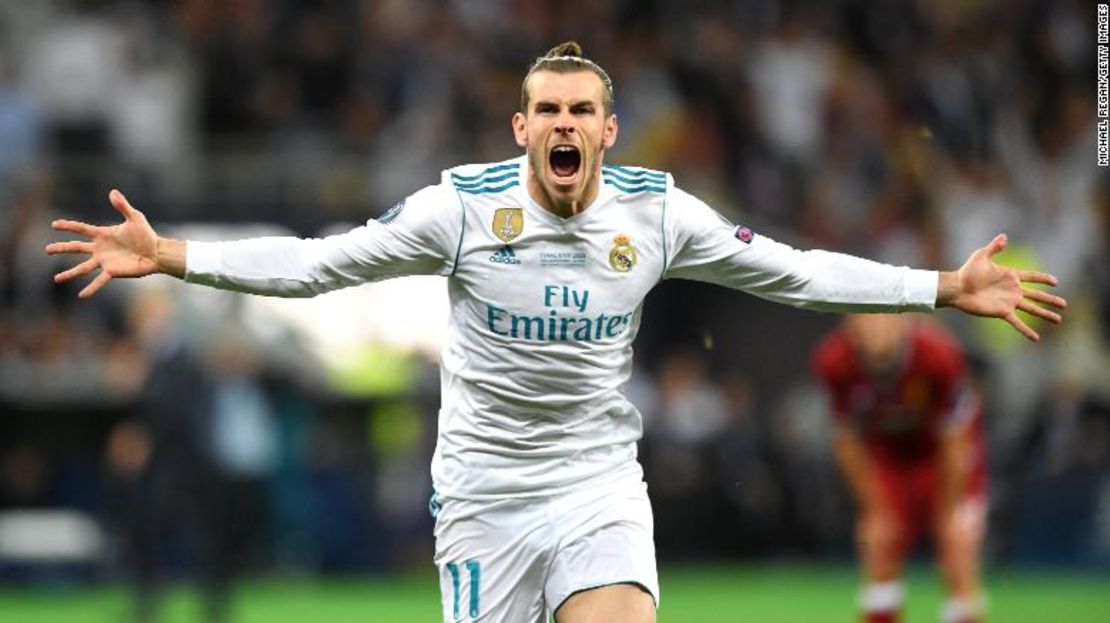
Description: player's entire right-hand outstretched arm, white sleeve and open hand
664,188,1067,341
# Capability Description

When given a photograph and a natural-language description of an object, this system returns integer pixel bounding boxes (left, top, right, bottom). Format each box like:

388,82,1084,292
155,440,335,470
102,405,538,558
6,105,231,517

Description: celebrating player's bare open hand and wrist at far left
47,190,185,299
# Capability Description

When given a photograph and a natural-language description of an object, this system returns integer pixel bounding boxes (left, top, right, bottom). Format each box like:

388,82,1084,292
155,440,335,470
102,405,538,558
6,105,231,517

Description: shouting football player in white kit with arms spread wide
47,42,1063,623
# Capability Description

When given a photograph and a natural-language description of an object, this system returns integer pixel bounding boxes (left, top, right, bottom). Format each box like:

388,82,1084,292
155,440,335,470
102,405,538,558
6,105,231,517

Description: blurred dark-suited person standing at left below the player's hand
108,292,233,623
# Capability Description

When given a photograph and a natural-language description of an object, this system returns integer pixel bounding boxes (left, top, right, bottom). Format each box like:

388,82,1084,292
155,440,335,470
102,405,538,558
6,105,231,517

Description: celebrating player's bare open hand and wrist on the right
937,233,1068,342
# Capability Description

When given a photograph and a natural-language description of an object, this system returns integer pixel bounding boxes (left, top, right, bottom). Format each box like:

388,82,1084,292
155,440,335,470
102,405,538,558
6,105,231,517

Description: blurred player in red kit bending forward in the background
814,314,987,623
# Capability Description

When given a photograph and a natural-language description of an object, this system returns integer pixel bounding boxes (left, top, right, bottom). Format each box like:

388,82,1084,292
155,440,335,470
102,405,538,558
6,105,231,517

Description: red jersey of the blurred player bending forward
813,322,983,470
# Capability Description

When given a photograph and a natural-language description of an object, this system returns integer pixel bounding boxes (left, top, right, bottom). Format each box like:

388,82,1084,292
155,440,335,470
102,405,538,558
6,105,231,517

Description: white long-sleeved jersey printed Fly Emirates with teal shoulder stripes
186,157,937,500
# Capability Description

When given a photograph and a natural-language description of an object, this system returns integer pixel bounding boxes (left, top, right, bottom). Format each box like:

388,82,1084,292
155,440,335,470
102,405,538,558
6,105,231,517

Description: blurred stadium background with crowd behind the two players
0,0,1110,623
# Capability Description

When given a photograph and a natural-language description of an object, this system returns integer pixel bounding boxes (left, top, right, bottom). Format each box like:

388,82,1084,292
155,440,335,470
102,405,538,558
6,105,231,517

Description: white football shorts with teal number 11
432,482,659,623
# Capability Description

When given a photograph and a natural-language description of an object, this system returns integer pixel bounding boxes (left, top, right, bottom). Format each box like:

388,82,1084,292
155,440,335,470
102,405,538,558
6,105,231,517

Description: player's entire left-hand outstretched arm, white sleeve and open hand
47,184,462,298
